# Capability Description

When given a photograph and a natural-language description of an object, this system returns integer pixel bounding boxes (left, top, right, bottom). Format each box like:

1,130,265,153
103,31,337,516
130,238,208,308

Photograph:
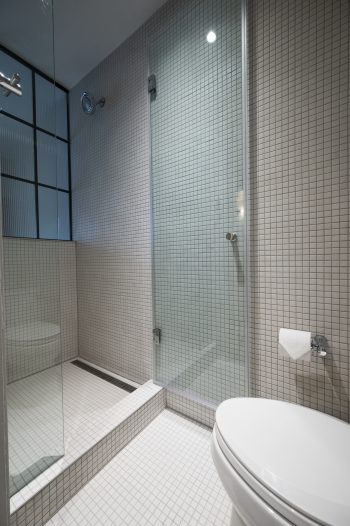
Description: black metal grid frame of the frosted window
0,44,73,240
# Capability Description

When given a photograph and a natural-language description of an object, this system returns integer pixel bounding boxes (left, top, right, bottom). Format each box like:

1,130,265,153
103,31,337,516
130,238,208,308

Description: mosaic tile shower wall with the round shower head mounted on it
70,30,152,383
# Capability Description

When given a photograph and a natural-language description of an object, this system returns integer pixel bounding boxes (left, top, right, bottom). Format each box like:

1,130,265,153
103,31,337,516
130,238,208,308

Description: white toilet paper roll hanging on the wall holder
278,329,311,362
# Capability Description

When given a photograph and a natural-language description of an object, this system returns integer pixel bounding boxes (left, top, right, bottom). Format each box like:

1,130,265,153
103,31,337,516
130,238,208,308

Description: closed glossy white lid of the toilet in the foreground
216,398,350,526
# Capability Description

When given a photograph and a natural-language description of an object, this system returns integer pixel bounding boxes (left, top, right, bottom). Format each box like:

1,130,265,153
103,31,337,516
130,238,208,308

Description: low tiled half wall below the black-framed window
3,238,78,382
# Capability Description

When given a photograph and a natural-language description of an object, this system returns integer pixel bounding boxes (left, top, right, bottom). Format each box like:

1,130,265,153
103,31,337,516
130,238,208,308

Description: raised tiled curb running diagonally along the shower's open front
10,364,166,526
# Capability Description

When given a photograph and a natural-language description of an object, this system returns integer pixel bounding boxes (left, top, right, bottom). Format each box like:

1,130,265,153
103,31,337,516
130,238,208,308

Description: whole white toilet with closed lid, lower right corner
211,398,350,526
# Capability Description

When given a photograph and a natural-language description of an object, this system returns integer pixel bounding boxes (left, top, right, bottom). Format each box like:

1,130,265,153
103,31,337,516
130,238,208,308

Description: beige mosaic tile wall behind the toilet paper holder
249,0,350,420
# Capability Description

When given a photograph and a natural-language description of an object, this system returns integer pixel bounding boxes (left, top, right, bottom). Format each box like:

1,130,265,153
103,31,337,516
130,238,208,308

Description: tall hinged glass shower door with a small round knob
150,0,247,406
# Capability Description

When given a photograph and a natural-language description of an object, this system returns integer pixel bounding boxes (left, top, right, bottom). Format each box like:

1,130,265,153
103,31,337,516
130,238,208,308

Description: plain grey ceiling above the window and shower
0,0,166,89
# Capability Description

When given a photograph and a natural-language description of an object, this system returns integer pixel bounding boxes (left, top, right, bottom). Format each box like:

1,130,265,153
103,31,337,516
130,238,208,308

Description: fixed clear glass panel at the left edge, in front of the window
0,0,64,495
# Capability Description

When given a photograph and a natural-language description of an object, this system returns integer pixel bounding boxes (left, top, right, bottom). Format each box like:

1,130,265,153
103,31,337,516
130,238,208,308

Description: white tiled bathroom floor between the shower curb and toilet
47,410,231,526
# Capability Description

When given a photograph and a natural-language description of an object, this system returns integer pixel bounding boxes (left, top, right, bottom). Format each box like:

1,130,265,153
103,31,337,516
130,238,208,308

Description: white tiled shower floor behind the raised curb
7,362,129,500
